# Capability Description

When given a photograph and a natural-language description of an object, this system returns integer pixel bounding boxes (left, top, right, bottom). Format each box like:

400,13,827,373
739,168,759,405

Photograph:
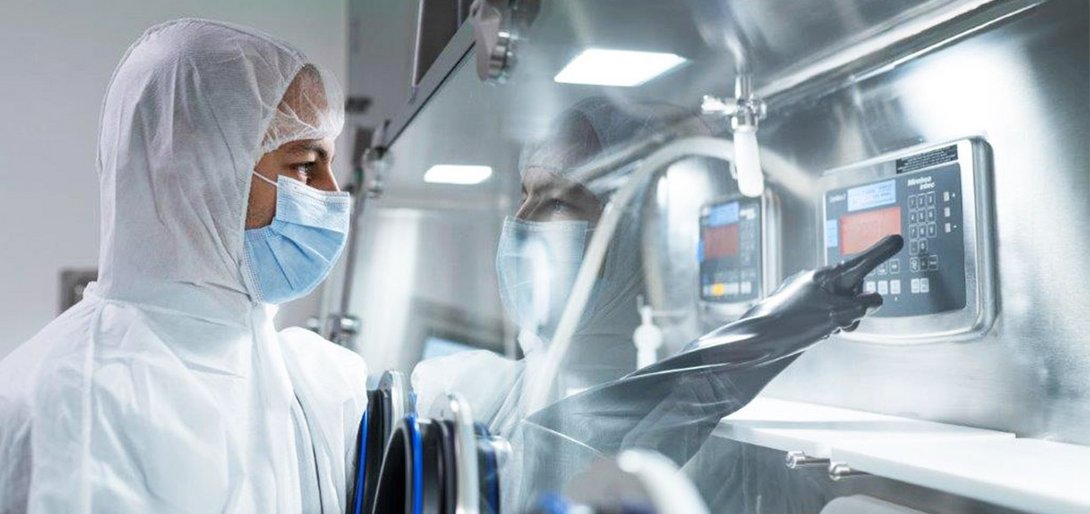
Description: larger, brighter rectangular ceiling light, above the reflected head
553,48,686,87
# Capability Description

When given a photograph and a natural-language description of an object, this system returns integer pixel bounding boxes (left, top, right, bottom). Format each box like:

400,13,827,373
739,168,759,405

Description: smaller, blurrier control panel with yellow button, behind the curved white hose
697,193,779,321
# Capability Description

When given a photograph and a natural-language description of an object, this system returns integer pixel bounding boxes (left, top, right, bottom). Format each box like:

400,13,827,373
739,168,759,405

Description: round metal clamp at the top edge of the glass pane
470,0,541,84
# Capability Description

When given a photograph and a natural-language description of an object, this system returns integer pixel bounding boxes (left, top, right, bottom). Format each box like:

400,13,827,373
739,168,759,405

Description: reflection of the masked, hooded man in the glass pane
413,97,693,433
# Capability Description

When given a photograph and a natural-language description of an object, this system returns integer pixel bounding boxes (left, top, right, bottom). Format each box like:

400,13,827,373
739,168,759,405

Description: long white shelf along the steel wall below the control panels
713,397,1090,514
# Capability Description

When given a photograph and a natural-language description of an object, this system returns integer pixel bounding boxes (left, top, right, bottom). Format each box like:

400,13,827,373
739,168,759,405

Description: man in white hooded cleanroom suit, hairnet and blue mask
0,20,366,514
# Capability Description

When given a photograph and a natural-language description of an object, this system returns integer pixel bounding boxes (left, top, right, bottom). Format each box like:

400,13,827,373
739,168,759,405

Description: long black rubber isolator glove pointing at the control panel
523,235,905,464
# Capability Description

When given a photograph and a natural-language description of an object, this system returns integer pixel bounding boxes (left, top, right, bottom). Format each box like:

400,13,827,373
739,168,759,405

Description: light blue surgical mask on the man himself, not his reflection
243,173,352,304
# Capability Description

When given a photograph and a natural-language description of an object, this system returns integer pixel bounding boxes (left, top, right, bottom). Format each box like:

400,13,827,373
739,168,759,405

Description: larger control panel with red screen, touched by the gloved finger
820,139,995,342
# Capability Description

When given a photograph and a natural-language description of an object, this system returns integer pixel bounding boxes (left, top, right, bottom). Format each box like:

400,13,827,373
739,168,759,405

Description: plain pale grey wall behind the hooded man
0,0,347,357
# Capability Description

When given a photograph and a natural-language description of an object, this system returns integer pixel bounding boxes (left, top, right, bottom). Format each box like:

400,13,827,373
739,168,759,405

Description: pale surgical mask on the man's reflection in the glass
496,218,590,340
